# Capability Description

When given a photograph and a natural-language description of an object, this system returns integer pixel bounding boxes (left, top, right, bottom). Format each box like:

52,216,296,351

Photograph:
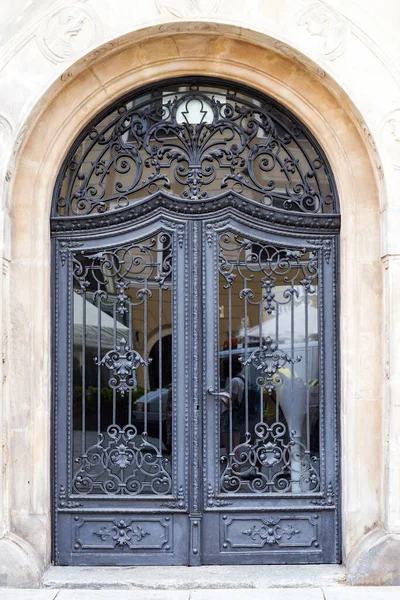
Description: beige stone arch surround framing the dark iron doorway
2,28,382,577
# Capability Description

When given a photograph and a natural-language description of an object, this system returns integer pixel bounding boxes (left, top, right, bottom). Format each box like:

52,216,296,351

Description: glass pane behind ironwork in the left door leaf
72,234,172,495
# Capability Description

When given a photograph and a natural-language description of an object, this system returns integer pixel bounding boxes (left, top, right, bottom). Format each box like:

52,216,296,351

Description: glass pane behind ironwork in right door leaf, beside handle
219,233,319,493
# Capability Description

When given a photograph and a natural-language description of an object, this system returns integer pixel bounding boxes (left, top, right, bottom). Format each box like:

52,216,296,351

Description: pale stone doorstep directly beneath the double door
42,565,346,590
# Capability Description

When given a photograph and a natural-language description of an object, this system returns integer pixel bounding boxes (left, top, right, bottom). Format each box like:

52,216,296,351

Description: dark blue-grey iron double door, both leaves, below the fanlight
53,210,340,565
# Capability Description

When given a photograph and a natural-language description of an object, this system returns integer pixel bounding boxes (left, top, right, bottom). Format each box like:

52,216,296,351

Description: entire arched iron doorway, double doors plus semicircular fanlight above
52,77,340,565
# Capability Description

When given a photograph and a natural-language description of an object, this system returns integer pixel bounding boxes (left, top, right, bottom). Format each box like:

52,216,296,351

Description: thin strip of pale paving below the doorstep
0,586,400,600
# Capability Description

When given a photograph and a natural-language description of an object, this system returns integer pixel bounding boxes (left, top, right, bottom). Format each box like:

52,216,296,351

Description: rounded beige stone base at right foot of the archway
347,529,400,585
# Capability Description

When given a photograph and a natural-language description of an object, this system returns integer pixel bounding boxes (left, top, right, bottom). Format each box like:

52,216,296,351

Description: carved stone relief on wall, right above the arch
297,4,350,60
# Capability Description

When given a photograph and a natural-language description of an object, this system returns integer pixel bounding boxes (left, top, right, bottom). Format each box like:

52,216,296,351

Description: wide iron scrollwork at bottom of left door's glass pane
73,425,172,496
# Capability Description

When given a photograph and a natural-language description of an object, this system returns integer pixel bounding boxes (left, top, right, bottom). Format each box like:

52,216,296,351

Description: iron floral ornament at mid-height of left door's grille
94,338,151,396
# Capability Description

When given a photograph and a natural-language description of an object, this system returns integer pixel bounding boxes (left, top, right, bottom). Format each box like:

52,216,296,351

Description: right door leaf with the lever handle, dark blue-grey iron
203,220,338,564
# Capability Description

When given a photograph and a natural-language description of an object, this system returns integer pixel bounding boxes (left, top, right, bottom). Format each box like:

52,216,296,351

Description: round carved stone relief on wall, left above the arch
36,6,100,64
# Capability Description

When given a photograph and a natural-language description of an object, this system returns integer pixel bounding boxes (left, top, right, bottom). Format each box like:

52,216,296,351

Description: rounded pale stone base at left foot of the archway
0,534,43,588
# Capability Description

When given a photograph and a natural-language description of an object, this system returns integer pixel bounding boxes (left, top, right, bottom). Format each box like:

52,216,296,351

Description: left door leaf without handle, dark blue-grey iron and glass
55,222,188,564
